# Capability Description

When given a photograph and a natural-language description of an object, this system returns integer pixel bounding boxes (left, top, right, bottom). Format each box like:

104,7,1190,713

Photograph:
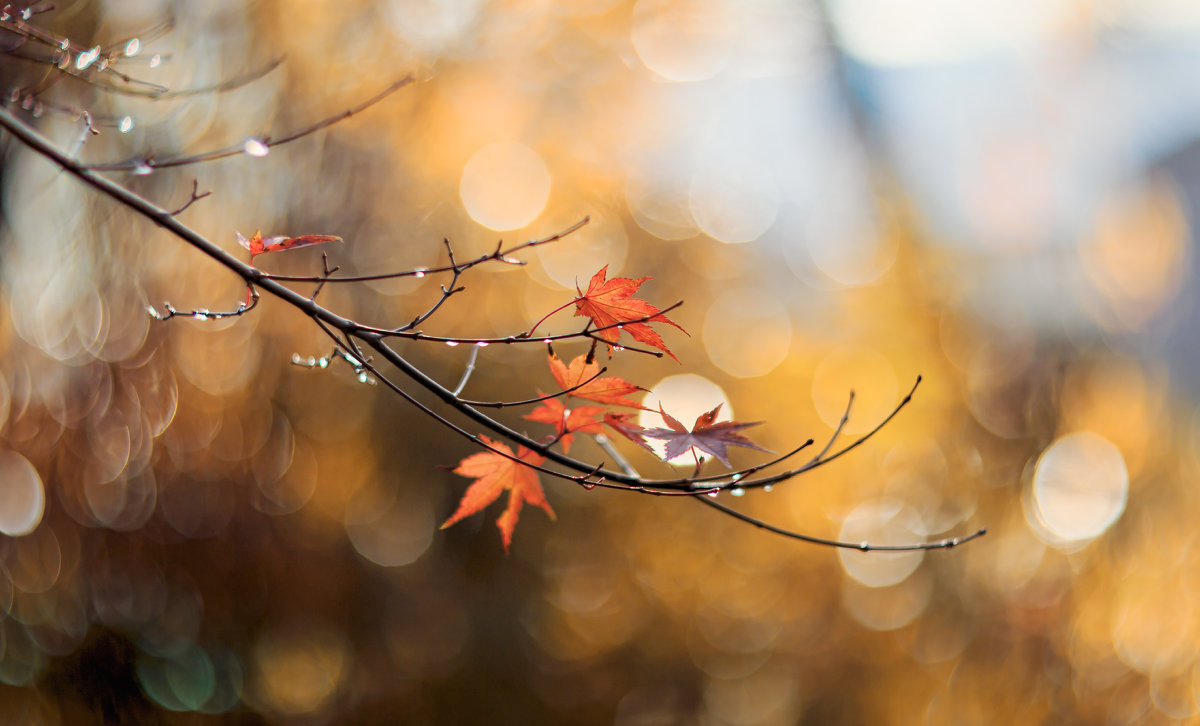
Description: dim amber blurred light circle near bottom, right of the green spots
253,624,353,715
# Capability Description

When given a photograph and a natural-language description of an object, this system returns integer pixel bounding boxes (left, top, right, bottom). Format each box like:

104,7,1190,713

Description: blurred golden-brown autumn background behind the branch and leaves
0,0,1200,726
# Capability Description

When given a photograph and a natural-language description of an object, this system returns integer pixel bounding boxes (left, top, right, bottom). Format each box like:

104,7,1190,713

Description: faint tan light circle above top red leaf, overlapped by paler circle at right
625,158,698,240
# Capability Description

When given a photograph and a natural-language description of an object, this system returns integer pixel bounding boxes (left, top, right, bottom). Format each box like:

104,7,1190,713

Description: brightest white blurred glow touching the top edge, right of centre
829,0,1064,66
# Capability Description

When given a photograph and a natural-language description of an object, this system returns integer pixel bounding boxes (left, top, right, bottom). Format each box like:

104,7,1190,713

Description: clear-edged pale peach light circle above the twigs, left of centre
458,142,550,230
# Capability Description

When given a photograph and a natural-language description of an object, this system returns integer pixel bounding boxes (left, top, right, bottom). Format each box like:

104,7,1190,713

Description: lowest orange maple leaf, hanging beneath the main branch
442,436,556,552
